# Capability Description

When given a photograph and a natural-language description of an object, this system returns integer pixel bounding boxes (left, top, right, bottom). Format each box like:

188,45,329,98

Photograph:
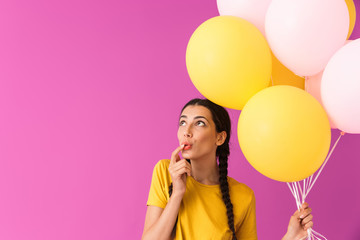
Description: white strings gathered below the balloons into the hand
287,132,345,240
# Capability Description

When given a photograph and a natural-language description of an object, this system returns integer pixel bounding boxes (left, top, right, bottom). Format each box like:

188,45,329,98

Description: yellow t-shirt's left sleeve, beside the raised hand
147,159,171,208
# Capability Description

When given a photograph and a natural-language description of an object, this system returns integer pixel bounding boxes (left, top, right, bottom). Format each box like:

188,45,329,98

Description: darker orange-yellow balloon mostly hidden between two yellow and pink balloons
269,53,305,90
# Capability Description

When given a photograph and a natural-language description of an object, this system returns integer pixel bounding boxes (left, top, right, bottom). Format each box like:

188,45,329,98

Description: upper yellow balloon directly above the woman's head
186,16,271,110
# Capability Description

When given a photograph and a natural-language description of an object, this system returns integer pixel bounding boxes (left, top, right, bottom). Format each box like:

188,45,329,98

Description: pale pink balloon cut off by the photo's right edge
321,39,360,133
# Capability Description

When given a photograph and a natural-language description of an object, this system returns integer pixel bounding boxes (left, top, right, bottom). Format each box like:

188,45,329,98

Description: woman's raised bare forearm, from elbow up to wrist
142,193,183,240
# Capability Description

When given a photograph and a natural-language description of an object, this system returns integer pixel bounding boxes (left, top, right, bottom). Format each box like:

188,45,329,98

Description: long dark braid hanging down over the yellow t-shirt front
217,142,237,240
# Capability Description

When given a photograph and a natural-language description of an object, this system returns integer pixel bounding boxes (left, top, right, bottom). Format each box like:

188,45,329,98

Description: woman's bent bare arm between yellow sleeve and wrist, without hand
141,193,183,240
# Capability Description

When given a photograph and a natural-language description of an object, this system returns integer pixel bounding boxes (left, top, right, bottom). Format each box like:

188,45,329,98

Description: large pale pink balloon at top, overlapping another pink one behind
265,0,349,76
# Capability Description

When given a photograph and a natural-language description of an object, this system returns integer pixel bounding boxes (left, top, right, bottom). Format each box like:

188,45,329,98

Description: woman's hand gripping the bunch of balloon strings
283,203,314,240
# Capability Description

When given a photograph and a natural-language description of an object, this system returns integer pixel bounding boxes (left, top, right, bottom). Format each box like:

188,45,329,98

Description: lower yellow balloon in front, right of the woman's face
238,85,331,182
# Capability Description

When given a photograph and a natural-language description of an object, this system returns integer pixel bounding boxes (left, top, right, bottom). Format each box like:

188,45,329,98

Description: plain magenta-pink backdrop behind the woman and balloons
0,0,360,240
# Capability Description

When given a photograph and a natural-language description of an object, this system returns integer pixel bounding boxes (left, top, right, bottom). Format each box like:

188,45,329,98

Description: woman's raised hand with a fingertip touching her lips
169,145,191,195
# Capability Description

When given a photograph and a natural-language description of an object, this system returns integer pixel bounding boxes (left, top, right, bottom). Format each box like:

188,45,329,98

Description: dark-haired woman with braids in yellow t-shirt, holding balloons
142,99,313,240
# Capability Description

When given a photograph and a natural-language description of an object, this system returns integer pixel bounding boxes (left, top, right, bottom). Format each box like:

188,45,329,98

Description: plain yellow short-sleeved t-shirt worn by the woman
147,159,257,240
